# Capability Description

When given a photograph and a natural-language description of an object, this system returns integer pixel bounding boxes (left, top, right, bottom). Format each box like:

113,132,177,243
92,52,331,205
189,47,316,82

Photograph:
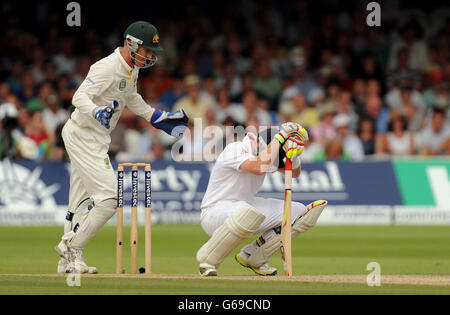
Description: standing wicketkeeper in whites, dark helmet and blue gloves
55,21,188,273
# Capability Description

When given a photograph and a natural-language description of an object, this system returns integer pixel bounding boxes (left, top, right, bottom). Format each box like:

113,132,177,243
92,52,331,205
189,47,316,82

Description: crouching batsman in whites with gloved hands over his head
197,122,327,276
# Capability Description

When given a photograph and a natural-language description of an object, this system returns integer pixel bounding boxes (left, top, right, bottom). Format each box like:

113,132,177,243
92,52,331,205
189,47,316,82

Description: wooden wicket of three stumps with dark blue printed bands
116,163,152,274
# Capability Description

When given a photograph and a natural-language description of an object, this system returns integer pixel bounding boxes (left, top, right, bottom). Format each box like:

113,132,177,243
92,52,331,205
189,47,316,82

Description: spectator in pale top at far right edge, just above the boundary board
420,108,450,155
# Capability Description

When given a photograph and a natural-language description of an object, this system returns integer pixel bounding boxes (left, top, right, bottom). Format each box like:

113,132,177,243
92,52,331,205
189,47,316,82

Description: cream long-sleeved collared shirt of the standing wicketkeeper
71,47,155,137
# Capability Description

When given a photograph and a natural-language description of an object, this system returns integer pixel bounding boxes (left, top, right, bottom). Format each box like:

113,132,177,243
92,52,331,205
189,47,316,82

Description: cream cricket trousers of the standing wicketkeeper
62,119,117,211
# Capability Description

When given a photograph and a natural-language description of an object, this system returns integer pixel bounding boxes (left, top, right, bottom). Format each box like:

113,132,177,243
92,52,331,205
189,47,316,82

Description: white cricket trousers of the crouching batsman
200,197,306,236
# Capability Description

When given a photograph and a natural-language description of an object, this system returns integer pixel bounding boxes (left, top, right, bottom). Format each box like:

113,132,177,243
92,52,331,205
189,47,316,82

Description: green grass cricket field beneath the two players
0,225,450,295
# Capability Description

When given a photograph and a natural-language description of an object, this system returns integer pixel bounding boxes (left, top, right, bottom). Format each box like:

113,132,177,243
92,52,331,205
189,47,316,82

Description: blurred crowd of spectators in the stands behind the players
0,0,450,161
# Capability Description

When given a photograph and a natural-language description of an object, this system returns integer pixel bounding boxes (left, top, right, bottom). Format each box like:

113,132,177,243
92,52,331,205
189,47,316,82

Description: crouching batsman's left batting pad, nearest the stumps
197,206,266,268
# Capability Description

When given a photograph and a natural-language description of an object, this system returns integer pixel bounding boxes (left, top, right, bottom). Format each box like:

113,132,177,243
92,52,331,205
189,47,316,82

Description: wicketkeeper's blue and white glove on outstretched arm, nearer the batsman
151,109,189,138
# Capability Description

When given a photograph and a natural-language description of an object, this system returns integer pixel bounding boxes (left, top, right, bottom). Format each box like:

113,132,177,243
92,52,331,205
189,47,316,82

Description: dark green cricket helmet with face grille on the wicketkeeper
123,21,163,68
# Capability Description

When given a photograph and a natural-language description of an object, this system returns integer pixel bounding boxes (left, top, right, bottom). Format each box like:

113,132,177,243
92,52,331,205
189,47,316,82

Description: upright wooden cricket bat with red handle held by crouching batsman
280,157,292,277
